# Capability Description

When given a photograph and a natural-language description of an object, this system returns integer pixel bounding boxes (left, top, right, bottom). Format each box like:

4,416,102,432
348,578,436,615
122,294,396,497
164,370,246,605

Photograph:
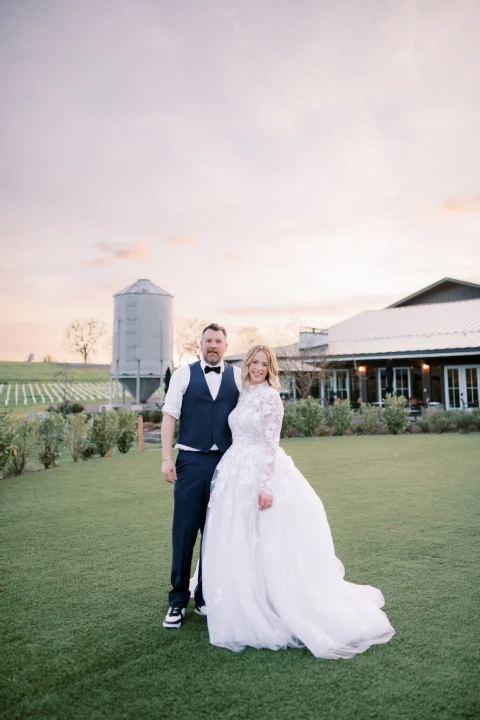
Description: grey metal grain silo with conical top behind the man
110,280,173,404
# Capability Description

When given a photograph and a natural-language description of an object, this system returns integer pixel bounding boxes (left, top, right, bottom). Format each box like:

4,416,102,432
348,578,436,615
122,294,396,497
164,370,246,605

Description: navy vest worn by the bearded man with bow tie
177,362,239,452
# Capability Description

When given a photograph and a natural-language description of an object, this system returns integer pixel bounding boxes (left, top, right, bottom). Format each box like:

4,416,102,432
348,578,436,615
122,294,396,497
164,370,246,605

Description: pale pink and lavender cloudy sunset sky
0,0,480,360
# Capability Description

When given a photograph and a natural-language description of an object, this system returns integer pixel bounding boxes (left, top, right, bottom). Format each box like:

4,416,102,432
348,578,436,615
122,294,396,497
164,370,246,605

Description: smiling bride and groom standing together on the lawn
162,324,395,659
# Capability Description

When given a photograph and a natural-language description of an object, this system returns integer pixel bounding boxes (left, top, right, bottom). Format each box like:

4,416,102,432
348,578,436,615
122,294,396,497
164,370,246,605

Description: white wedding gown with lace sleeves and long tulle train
202,382,395,658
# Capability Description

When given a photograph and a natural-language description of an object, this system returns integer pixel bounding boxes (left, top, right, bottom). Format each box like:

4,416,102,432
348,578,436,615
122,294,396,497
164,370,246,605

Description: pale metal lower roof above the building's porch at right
327,299,480,356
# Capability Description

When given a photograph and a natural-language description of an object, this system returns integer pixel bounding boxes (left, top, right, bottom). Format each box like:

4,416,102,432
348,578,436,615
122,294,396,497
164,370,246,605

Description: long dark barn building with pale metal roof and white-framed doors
228,278,480,410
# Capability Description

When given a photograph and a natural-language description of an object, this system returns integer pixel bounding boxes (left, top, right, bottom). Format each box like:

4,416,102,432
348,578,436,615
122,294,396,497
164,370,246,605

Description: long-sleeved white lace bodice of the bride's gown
228,381,283,494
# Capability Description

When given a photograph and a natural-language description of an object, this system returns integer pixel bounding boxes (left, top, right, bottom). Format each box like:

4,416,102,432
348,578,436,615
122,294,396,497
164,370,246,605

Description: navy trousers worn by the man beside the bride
168,450,222,608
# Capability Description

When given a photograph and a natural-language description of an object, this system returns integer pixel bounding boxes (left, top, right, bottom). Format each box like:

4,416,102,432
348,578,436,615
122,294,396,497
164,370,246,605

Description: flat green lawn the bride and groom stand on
0,434,480,720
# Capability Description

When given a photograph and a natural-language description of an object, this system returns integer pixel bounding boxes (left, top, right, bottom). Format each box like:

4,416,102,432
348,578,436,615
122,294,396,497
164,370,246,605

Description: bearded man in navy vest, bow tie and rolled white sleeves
162,323,241,628
